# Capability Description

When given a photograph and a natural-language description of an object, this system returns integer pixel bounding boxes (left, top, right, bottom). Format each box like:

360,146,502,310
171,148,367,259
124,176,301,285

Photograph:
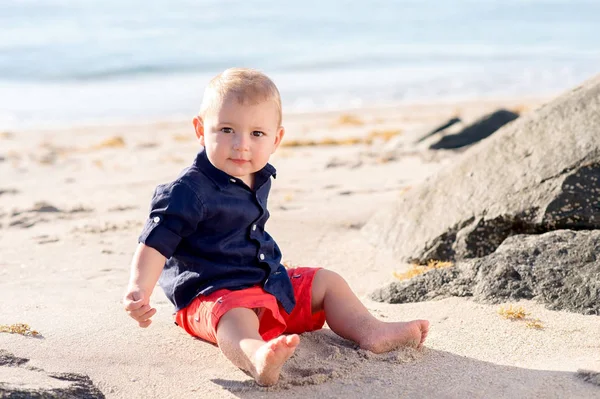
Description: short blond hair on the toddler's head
200,68,282,125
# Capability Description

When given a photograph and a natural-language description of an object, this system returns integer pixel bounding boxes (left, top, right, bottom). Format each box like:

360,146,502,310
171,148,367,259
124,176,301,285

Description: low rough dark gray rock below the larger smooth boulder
371,230,600,315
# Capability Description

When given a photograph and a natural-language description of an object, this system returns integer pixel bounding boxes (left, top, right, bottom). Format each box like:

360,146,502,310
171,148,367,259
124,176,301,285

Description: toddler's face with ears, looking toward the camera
194,98,284,187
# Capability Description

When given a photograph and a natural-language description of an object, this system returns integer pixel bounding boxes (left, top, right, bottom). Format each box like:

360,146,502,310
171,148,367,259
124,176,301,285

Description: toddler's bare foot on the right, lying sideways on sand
360,320,429,353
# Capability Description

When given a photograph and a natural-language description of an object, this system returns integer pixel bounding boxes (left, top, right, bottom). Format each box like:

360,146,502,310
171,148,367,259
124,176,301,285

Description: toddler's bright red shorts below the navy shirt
175,267,325,344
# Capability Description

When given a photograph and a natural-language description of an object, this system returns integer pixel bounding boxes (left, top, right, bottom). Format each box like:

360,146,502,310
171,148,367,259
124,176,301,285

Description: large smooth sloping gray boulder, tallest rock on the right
363,75,600,263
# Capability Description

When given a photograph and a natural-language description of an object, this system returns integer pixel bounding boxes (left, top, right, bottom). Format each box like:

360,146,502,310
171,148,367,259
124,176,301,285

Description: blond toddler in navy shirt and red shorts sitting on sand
124,68,429,385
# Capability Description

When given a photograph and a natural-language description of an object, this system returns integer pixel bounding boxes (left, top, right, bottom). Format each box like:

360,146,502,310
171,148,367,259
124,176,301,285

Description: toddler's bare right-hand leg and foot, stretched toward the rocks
312,269,429,353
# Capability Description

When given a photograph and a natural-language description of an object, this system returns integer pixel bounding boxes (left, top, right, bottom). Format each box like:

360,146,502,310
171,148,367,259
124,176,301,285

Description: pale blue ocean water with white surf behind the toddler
0,0,600,129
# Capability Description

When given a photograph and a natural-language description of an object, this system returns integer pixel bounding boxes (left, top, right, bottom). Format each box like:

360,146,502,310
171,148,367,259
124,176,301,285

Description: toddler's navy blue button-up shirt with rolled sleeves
139,150,296,313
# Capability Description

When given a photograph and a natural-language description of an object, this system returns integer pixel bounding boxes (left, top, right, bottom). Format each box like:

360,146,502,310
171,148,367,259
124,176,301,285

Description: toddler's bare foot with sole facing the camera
253,334,300,386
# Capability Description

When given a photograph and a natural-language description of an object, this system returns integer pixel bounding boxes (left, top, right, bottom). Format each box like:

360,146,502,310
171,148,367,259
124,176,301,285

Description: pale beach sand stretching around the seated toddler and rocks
0,98,600,398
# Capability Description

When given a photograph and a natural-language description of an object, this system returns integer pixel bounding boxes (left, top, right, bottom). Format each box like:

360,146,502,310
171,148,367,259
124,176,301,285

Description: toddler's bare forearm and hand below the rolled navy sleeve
123,243,166,327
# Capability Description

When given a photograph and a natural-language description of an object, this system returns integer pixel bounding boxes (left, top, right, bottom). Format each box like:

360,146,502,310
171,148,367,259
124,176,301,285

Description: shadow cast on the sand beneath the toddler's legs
211,330,600,399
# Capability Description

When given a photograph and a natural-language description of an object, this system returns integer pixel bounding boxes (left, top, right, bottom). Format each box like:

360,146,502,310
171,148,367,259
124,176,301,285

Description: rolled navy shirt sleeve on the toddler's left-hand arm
138,181,204,259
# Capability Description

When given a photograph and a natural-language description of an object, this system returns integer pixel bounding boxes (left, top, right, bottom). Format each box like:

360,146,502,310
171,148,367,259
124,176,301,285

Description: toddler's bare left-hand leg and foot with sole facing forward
217,308,300,385
